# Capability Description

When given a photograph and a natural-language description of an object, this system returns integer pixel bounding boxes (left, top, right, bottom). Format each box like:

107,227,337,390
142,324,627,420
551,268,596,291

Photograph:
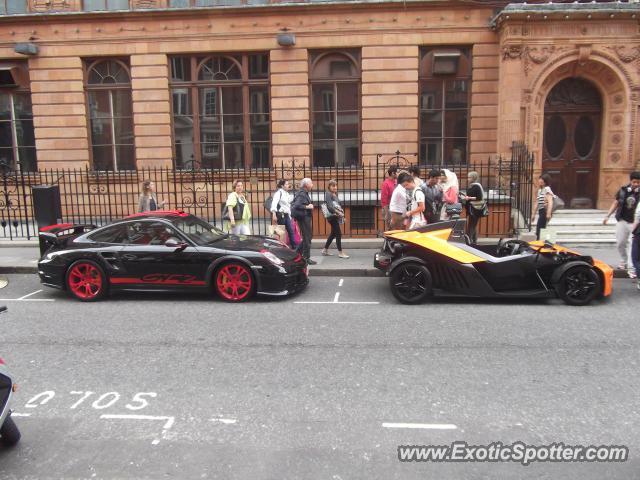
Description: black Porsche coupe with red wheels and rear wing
38,211,308,302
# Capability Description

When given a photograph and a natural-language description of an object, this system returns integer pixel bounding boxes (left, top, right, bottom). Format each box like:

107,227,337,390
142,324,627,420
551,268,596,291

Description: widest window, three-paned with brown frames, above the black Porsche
171,54,271,169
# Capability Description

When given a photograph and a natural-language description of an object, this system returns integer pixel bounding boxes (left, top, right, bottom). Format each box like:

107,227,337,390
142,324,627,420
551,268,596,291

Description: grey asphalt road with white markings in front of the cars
0,275,640,480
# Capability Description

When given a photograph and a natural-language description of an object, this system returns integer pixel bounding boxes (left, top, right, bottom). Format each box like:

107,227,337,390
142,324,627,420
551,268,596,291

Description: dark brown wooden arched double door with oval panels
542,78,602,208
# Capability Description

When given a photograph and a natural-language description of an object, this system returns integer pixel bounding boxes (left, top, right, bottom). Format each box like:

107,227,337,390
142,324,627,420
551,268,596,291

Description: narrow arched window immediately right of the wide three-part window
309,51,360,167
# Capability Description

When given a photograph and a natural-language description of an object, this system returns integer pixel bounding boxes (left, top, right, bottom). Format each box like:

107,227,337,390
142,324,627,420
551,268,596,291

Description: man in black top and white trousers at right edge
602,172,640,278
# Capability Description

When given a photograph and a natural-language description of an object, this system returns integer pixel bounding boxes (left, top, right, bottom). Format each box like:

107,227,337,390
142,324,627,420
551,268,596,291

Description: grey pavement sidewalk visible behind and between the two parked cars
0,239,627,277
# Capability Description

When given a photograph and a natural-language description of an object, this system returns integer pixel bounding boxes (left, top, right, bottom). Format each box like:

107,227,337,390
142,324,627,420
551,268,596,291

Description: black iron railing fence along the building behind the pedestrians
0,144,533,239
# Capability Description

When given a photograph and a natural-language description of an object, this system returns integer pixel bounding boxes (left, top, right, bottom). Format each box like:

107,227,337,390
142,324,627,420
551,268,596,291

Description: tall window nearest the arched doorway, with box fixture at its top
420,47,471,165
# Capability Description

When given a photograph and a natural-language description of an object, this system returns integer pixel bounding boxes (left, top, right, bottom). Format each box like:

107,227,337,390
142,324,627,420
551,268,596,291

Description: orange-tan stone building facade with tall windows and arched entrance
0,0,640,208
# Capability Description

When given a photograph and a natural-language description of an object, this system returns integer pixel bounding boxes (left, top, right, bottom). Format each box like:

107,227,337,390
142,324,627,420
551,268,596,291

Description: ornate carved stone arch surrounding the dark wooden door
524,49,638,207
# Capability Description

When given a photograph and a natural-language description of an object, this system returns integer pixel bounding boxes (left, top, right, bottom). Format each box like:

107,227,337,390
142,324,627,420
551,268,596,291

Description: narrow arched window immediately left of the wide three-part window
86,59,136,171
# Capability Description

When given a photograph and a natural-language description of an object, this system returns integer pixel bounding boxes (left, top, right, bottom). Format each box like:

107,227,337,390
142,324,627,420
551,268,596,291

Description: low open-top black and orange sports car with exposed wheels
374,219,613,305
